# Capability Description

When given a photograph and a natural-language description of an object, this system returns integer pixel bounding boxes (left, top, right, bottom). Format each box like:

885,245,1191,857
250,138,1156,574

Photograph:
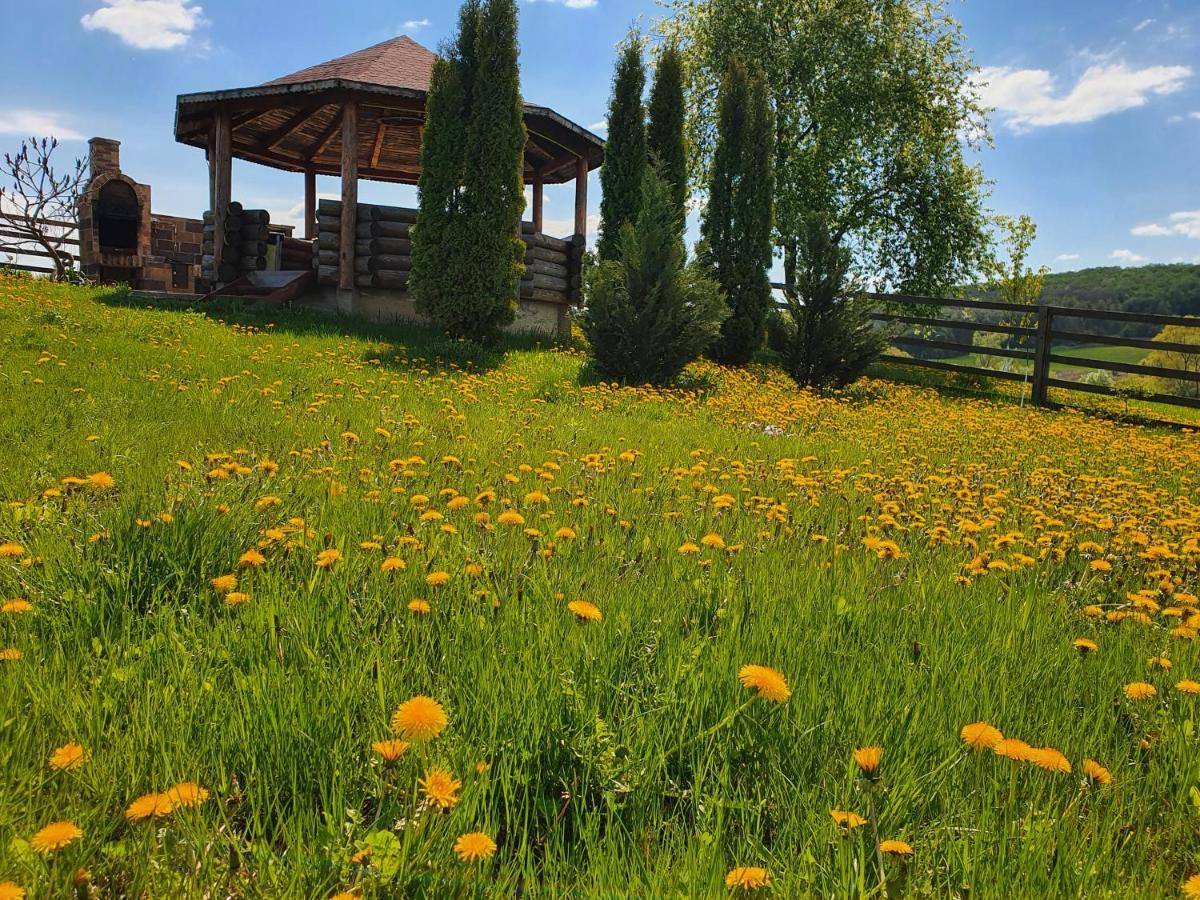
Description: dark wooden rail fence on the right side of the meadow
774,284,1200,409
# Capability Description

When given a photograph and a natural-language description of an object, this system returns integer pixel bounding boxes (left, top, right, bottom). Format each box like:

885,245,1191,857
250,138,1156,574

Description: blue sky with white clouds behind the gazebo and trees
0,0,1200,271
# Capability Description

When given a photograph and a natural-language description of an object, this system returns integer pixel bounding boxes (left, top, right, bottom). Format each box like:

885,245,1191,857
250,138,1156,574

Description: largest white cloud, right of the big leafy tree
973,62,1192,132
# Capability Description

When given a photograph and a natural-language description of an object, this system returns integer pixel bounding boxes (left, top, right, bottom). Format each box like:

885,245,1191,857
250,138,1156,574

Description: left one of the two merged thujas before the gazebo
408,0,481,332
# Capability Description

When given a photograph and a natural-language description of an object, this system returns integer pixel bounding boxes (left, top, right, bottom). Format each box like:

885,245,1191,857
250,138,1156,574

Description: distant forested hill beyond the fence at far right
972,264,1200,337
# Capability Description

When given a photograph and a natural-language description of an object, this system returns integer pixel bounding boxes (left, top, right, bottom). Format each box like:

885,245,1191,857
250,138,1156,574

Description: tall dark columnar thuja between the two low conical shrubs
701,59,774,365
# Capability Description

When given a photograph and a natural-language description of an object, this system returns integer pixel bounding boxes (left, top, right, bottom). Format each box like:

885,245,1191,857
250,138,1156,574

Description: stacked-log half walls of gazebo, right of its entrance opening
313,200,584,304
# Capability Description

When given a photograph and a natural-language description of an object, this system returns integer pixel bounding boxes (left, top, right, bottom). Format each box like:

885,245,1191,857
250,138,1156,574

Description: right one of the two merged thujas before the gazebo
451,0,526,342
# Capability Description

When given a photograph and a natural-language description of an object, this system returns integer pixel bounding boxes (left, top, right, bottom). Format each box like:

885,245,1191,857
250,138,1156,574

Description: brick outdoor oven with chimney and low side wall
79,138,204,294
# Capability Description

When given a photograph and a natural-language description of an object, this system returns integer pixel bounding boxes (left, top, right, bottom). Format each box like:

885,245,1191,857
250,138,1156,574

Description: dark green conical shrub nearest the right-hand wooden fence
779,217,884,389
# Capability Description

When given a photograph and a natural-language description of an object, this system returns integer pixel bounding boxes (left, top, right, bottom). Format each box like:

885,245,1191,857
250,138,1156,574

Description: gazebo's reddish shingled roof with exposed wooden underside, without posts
175,35,604,184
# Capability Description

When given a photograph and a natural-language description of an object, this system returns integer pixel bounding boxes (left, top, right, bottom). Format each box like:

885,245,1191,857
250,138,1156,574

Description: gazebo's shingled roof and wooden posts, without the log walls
175,36,604,296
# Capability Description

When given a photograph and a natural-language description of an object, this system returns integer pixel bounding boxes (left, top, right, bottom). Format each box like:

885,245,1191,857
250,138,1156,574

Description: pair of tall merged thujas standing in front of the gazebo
410,0,526,343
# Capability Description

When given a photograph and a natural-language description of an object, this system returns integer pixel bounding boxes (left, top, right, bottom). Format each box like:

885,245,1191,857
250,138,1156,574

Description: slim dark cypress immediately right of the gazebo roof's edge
596,36,646,259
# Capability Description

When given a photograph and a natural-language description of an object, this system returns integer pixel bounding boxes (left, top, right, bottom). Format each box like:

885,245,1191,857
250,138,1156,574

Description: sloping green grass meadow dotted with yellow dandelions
0,277,1200,899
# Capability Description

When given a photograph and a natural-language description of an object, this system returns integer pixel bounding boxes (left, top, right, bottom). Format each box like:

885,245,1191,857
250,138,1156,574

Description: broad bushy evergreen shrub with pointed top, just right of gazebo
582,173,727,384
